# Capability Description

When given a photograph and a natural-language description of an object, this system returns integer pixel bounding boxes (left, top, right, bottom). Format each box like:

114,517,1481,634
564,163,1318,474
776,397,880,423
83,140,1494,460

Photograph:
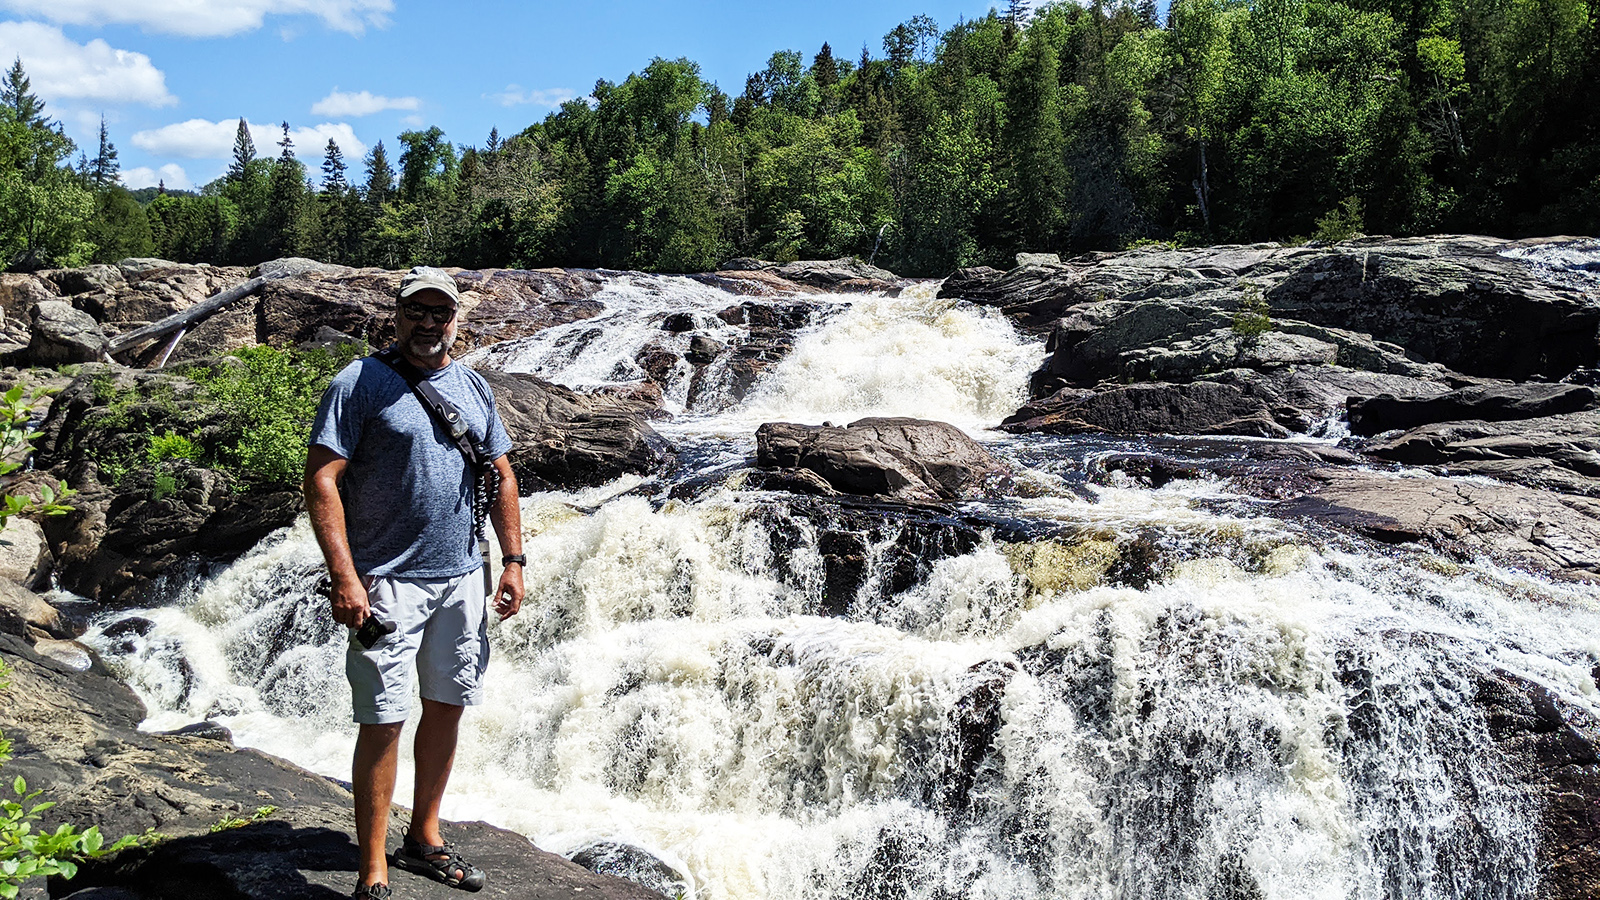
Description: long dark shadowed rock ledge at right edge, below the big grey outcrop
1350,383,1600,436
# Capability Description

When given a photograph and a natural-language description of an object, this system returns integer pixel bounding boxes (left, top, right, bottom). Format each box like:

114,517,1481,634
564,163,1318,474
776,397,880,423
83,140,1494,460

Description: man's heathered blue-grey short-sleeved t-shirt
310,357,510,578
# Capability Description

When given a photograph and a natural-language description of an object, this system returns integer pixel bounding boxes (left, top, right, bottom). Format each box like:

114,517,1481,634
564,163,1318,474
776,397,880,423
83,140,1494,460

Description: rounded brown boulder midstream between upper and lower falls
755,418,1006,501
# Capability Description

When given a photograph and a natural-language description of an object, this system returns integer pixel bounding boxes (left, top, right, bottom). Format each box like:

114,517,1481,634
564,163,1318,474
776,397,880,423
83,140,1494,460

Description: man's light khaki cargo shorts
344,569,490,725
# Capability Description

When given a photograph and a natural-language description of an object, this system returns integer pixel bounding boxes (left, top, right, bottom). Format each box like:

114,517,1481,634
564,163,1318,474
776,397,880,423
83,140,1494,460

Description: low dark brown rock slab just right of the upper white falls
1002,381,1288,437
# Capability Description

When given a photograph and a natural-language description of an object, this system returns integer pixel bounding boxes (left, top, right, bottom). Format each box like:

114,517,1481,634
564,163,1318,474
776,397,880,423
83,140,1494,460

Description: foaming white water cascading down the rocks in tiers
84,275,1600,900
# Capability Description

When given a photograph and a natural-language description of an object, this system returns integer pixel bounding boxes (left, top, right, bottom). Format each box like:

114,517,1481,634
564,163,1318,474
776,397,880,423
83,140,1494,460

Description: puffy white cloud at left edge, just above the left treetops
0,22,178,106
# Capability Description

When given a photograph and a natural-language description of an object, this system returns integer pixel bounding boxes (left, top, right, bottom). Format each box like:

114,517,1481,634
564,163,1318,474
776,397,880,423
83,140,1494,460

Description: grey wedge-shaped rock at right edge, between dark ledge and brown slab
1365,408,1600,496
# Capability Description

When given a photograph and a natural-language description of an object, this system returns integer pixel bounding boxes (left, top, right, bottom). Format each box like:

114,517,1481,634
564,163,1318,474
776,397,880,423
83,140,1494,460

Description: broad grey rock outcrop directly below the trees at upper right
941,235,1600,380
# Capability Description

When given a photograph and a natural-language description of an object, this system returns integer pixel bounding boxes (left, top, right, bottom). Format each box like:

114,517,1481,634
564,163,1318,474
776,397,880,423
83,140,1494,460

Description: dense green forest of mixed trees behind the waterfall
0,0,1600,275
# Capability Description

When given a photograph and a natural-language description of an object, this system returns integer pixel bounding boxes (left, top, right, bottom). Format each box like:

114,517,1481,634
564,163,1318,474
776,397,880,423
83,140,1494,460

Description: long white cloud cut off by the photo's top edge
0,0,394,37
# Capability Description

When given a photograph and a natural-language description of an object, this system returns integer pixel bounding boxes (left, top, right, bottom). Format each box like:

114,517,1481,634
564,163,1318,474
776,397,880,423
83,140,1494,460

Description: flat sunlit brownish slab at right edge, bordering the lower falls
1270,469,1600,581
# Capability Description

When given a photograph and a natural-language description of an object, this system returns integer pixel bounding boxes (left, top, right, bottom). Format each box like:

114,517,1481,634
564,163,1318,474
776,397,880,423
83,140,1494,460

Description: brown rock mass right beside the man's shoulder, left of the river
480,370,674,490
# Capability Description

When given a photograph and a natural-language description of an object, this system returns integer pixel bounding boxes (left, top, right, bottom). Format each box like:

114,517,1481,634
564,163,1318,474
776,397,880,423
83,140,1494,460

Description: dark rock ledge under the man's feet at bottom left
0,634,661,900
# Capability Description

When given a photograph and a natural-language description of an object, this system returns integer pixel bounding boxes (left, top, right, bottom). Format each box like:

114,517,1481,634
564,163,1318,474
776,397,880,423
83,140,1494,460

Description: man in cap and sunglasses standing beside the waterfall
306,266,523,900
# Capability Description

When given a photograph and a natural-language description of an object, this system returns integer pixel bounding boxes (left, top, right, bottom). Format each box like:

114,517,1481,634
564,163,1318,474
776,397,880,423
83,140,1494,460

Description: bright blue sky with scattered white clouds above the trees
0,0,1024,187
